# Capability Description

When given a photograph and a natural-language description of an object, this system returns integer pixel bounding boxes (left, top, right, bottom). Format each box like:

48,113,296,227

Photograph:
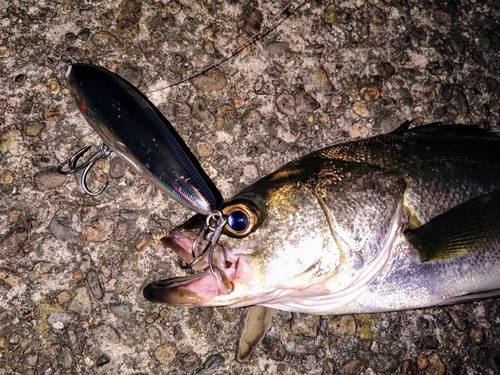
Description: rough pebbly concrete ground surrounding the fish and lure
0,0,500,375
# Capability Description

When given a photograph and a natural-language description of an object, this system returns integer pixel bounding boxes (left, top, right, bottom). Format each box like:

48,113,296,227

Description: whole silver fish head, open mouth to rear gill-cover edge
144,154,406,314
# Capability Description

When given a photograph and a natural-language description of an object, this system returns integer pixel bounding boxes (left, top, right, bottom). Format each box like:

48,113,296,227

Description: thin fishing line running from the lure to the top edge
146,0,307,94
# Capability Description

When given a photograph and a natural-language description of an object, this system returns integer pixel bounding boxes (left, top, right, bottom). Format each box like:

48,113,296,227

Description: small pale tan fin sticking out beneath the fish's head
236,306,276,362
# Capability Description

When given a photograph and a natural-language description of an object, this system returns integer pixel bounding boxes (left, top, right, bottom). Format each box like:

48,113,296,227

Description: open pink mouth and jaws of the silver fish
143,231,239,306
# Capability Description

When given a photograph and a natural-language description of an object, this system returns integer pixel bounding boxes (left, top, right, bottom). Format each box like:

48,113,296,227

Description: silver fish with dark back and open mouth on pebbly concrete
143,122,500,354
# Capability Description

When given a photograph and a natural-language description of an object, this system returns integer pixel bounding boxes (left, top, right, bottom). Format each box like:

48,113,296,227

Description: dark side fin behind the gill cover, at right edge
405,191,500,262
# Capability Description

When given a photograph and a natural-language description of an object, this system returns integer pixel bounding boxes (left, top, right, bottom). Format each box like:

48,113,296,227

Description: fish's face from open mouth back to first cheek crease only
144,163,341,307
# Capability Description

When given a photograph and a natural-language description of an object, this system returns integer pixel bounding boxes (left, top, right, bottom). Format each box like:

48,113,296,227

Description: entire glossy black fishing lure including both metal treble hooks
57,57,227,282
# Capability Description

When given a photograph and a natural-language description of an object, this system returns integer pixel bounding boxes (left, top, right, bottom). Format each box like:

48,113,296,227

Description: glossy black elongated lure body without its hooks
66,63,217,215
